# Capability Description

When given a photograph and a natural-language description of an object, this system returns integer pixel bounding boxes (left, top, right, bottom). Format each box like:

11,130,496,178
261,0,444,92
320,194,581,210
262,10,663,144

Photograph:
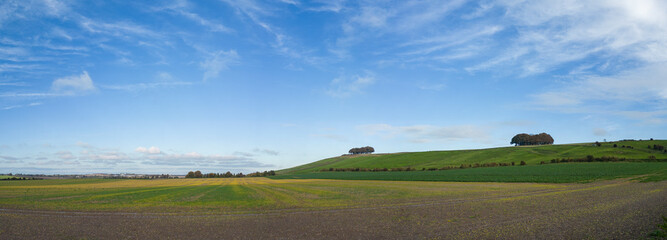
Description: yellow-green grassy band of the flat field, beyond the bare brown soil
0,178,559,212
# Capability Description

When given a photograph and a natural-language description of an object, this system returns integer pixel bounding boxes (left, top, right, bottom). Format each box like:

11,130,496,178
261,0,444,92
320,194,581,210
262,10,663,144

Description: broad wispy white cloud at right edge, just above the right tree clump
531,64,667,124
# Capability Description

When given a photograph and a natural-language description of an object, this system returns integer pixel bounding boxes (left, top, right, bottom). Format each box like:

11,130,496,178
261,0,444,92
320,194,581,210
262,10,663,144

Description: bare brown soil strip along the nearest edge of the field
0,180,667,239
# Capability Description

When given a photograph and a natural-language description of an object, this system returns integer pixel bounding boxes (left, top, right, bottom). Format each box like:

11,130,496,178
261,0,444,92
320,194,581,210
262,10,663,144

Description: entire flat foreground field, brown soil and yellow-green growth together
0,178,667,239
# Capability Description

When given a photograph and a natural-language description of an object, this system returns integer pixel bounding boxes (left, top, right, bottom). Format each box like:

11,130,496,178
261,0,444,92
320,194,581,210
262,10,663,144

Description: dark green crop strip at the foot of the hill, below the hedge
271,162,667,183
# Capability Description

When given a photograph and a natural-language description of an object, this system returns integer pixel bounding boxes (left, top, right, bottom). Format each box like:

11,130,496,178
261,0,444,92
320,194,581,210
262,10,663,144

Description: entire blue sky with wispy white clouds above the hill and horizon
0,0,667,174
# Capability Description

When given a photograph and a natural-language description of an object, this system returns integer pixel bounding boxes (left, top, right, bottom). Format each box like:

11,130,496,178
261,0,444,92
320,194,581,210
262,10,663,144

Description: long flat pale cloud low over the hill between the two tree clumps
358,124,489,143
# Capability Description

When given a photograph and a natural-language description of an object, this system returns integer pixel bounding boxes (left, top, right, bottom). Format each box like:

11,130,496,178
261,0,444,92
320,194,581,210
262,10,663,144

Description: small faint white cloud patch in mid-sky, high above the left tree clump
326,71,375,98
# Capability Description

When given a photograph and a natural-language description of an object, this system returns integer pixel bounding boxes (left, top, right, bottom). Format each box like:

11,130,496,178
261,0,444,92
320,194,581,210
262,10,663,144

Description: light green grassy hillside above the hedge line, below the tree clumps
276,140,667,175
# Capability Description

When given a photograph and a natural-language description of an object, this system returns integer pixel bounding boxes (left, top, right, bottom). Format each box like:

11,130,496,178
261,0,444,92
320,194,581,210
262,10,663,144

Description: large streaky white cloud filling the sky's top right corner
468,0,667,75
